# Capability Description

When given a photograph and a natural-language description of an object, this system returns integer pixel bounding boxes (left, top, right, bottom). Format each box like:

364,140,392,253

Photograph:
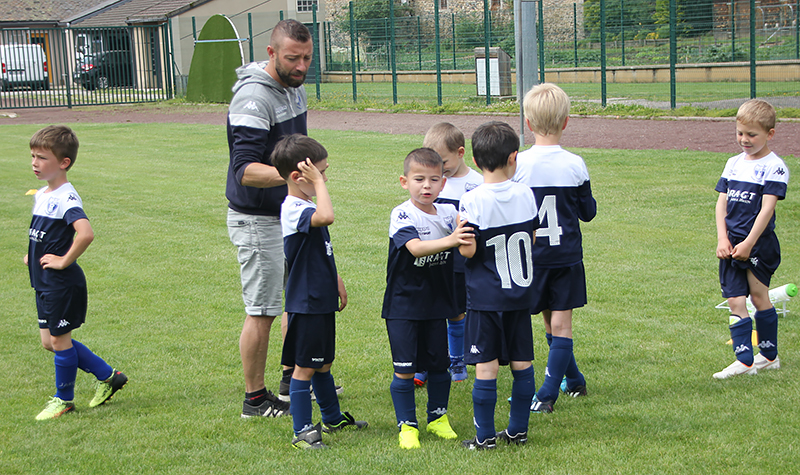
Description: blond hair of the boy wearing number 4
522,82,569,135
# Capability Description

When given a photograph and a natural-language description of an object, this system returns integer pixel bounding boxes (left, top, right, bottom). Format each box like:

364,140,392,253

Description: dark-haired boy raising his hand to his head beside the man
270,134,367,449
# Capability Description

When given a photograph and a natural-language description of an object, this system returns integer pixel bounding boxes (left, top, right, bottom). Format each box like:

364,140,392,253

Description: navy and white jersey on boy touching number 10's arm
381,200,458,320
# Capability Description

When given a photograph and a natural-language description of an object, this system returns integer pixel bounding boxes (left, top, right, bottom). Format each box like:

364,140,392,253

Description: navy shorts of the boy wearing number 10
464,309,533,365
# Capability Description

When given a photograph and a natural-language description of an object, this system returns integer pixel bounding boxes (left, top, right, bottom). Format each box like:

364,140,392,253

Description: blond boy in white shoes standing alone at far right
714,99,789,379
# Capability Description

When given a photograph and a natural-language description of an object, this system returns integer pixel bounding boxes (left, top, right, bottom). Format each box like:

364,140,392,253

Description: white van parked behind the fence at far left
0,44,50,91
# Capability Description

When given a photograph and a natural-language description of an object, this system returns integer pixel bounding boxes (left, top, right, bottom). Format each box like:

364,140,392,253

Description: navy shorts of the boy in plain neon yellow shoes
386,318,450,374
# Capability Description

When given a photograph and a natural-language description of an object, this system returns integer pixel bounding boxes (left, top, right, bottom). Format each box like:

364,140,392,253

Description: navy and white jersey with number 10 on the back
461,180,539,312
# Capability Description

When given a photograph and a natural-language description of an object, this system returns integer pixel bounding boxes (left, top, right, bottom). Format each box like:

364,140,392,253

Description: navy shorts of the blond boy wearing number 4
531,262,586,315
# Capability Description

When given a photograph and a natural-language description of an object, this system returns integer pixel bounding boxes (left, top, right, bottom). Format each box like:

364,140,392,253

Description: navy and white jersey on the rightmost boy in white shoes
714,152,789,239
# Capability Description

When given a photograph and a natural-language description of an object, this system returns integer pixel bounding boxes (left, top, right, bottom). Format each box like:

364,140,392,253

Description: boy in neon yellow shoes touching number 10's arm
381,148,470,449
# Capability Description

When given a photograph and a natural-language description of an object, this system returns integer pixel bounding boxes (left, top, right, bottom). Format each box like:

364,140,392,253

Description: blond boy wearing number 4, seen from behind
513,83,597,413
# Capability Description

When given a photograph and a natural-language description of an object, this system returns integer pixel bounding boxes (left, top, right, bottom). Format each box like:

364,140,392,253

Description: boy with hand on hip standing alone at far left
23,125,128,420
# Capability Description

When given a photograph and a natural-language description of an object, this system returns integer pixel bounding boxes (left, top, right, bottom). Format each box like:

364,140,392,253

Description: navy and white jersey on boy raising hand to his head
281,196,339,314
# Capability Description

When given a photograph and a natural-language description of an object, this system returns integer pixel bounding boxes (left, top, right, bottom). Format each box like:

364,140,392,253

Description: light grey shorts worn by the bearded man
228,208,286,316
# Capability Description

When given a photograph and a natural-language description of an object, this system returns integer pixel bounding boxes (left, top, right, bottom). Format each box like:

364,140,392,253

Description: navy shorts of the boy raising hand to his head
281,312,336,369
